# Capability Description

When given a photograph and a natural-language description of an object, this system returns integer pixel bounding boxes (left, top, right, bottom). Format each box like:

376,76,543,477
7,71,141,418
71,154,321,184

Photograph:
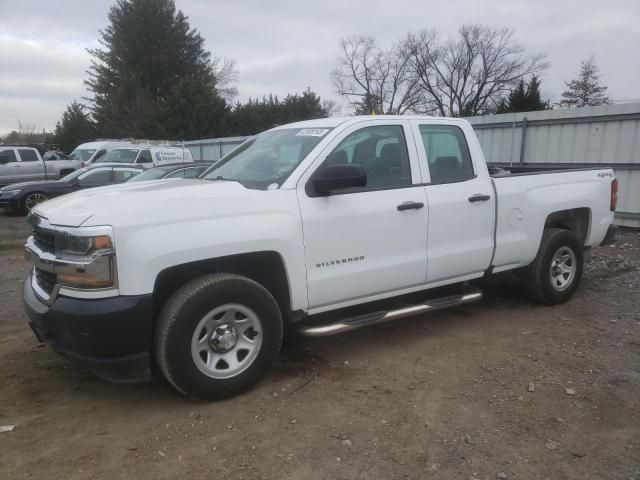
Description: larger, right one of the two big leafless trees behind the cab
404,25,548,117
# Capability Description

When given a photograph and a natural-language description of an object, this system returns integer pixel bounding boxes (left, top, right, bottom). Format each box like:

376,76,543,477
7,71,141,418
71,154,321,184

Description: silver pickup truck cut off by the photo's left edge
0,146,80,186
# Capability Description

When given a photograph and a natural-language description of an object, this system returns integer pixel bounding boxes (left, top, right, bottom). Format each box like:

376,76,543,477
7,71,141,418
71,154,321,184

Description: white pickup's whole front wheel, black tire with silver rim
155,273,283,401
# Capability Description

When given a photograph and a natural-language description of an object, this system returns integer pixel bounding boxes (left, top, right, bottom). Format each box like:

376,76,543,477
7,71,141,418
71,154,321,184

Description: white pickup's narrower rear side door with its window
412,120,495,283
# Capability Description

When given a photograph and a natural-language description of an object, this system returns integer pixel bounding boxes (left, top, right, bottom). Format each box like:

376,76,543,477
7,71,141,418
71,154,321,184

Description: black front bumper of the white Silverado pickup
22,273,152,382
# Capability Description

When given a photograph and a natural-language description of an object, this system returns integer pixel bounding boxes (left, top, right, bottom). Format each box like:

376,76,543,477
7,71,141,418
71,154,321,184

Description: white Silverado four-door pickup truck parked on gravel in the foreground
23,116,617,399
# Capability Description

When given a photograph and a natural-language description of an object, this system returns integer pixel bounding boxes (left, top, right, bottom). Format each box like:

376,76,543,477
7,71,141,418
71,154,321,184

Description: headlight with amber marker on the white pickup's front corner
55,227,116,289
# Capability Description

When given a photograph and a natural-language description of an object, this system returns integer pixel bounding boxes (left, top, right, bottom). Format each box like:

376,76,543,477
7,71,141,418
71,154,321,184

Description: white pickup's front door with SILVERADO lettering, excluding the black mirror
298,120,427,310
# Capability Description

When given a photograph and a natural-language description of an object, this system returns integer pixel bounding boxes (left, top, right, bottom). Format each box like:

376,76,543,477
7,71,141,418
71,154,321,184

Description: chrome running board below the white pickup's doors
298,291,482,337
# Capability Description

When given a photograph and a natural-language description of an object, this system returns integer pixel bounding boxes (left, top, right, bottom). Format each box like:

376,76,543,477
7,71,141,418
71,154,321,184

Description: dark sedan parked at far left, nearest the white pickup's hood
0,165,142,213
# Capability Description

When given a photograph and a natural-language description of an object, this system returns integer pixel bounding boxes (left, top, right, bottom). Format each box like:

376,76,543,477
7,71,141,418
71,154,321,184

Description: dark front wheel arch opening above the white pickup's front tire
153,250,291,322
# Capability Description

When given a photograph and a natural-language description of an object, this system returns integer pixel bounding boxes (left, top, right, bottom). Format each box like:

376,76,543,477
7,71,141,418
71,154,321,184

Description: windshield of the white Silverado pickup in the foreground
201,128,331,190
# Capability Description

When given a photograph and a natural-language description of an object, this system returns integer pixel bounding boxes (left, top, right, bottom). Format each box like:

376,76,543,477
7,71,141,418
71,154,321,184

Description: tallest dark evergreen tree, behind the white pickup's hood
85,0,228,140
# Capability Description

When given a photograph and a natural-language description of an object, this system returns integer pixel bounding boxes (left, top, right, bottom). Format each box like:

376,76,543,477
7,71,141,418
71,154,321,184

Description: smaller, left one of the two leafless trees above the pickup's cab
331,36,420,115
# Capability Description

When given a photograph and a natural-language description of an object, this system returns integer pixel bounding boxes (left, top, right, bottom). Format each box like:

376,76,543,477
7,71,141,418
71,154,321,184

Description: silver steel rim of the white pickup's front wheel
191,303,262,379
